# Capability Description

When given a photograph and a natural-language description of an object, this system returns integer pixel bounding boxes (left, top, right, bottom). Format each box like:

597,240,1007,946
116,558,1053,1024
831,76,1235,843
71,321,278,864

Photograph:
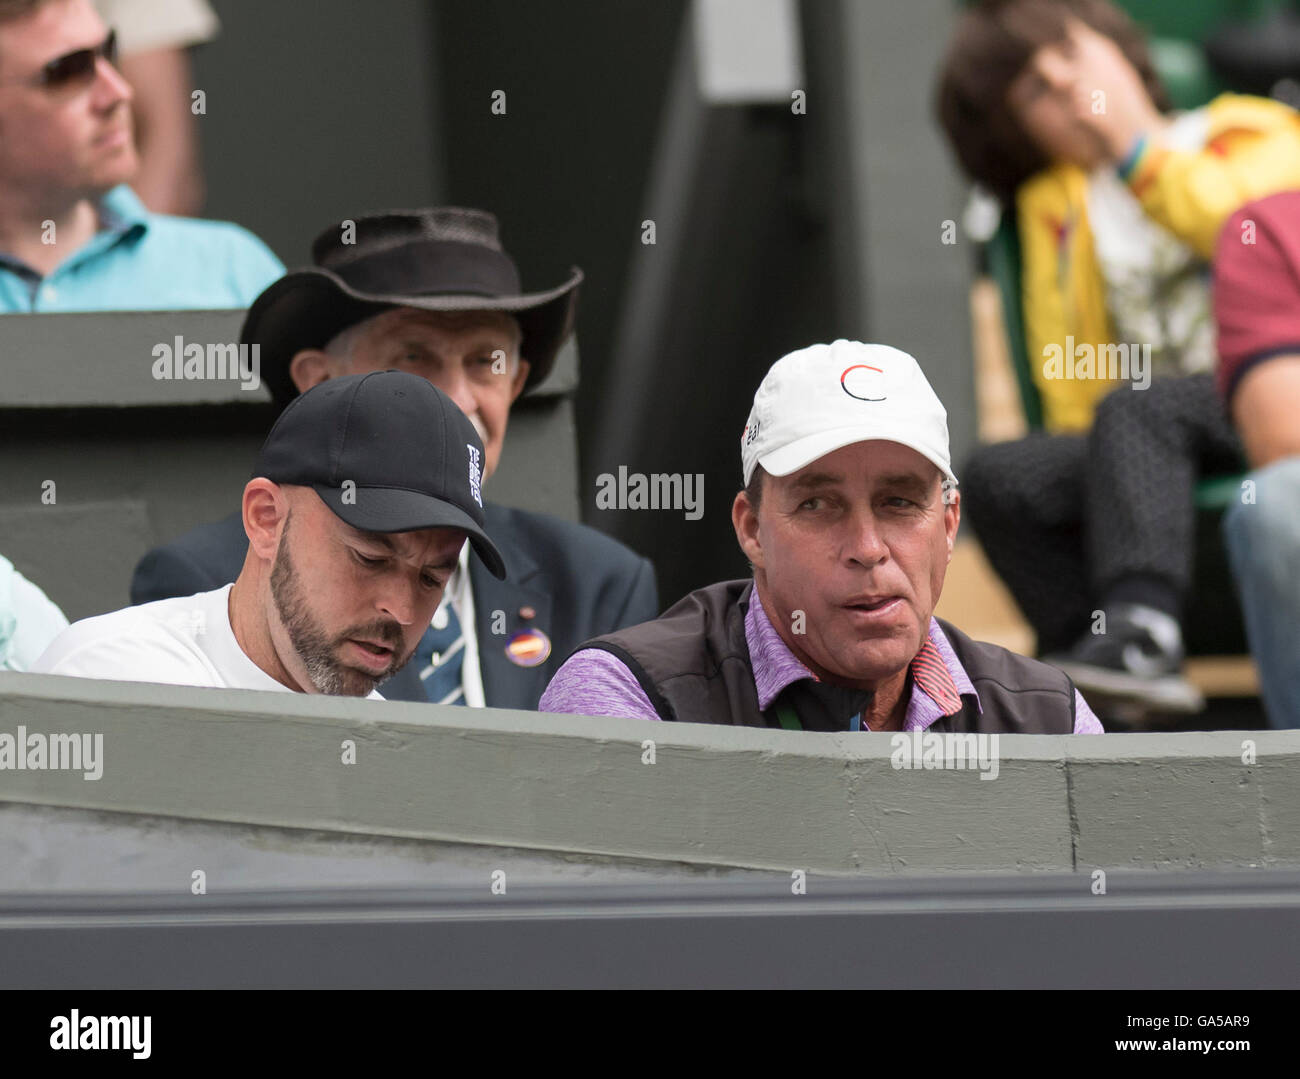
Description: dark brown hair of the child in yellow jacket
935,0,1171,205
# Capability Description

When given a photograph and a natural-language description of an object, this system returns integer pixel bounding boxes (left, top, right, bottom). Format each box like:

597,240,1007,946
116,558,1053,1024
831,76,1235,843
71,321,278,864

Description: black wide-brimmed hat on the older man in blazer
239,207,582,407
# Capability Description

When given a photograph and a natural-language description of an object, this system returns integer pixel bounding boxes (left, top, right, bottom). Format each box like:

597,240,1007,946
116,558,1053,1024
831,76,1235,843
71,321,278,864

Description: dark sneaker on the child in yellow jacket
1043,603,1205,712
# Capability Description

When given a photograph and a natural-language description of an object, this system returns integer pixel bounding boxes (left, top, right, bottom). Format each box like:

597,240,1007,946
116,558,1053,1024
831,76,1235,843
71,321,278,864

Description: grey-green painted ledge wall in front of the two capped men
0,673,1300,875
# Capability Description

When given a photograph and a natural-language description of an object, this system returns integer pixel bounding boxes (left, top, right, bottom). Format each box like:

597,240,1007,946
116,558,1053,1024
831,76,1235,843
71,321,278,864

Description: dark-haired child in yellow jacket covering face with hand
939,0,1300,711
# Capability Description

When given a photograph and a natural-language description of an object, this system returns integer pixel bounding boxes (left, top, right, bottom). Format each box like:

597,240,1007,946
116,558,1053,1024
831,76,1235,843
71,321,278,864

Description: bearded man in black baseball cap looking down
33,371,506,699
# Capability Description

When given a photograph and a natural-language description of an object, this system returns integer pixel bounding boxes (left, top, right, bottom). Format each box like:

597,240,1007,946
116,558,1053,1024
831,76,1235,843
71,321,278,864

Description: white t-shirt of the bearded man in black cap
31,585,384,701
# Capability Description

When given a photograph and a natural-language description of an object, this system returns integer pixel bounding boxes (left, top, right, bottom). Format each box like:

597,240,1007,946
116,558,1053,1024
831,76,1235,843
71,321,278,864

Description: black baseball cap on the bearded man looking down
254,371,506,579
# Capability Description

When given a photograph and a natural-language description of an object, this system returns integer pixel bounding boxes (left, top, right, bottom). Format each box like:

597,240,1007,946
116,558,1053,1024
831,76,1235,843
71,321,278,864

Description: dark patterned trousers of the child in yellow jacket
959,374,1244,653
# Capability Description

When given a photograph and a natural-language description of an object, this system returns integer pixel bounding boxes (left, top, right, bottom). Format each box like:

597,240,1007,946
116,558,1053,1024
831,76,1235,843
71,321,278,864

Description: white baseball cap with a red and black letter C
740,339,957,486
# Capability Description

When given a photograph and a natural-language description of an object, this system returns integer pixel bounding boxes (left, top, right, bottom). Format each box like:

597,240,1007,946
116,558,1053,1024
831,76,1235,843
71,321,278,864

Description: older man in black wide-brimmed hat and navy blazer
131,207,658,709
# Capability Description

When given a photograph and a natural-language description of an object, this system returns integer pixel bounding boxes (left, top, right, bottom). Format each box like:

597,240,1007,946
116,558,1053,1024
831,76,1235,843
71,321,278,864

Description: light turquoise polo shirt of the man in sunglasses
0,183,285,313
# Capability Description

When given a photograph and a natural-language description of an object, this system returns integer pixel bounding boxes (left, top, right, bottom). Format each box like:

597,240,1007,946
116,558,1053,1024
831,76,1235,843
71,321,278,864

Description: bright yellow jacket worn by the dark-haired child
1015,94,1300,432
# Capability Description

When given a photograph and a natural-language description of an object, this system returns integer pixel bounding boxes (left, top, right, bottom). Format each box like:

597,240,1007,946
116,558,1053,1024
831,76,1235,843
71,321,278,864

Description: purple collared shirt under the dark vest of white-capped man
537,592,1102,735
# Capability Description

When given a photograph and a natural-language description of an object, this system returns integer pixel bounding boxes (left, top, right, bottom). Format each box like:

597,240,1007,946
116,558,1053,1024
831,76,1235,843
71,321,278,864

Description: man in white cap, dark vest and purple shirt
540,341,1101,735
